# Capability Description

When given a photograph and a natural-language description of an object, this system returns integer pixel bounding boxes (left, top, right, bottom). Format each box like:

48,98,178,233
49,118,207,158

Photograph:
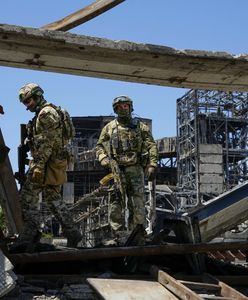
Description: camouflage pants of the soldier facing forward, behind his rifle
109,165,146,231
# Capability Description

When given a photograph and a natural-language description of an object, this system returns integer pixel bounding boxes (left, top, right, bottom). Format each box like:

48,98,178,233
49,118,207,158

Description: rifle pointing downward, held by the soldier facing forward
109,158,129,230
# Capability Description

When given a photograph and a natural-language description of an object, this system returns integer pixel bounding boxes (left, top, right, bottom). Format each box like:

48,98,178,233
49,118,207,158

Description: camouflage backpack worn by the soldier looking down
47,103,75,141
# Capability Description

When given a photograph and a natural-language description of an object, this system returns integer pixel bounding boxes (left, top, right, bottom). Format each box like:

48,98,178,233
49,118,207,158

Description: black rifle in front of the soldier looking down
15,124,29,187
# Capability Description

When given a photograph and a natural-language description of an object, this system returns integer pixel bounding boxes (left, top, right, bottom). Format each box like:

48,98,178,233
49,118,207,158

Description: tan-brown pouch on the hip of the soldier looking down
45,159,67,185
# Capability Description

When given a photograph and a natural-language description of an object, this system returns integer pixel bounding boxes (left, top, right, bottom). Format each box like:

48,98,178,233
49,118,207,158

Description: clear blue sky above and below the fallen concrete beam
0,0,248,171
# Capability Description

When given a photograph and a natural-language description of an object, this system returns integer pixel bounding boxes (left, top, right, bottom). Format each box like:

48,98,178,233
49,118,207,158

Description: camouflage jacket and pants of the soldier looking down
16,83,81,246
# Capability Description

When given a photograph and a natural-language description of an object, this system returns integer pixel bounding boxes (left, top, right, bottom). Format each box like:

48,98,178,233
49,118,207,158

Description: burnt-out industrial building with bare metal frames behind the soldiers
35,90,248,246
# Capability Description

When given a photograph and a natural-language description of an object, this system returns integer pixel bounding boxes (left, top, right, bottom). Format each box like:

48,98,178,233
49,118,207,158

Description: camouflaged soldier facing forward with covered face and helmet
96,96,158,241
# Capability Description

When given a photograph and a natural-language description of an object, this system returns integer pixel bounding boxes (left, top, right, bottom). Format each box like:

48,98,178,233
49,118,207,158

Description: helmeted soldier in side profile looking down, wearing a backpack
13,83,81,247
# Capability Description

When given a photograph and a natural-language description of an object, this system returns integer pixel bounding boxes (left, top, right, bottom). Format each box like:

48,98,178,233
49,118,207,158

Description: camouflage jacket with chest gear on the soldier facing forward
96,118,158,167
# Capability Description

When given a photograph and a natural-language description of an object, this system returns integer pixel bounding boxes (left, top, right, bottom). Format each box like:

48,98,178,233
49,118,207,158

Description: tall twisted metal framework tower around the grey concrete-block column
177,90,248,207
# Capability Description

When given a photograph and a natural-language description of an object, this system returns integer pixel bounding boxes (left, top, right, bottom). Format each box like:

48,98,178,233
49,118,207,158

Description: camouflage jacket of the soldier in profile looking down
27,103,64,168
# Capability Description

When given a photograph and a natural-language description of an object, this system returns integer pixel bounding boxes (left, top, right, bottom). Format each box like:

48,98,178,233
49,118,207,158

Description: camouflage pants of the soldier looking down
19,172,77,241
